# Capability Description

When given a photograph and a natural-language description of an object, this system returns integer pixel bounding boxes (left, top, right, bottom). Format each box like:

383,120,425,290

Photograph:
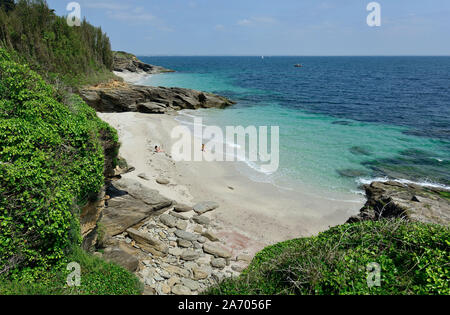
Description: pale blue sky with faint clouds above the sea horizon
48,0,450,56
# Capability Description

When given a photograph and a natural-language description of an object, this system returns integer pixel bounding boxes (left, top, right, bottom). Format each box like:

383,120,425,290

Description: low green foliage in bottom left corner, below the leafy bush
0,249,142,295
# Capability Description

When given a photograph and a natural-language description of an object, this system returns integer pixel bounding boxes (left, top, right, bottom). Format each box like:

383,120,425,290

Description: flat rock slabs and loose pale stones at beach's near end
94,178,251,295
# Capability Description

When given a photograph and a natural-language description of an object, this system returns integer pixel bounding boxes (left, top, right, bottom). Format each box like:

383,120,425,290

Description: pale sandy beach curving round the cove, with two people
98,112,364,255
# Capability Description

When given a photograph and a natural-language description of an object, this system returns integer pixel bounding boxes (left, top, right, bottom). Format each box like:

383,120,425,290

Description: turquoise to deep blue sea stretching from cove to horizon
141,57,450,193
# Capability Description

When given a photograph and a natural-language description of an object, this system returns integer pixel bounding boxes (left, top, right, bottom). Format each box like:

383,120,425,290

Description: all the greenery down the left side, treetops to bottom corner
0,0,142,294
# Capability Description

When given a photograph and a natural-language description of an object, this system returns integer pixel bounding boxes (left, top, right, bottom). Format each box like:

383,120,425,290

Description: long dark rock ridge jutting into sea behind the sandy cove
79,83,234,114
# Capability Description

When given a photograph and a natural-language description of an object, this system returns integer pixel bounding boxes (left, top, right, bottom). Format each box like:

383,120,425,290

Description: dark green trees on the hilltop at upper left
0,0,115,86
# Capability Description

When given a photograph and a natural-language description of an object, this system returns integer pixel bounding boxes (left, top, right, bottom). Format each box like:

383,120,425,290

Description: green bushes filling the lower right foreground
207,220,450,295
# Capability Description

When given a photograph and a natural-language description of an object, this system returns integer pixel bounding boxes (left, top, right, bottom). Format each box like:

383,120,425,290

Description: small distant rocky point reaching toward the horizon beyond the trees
113,51,174,74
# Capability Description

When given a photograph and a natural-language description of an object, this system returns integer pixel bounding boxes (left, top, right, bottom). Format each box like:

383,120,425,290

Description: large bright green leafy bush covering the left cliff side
0,49,117,279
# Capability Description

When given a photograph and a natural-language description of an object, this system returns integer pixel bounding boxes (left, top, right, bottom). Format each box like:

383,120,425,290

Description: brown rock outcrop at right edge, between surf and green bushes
347,181,450,226
